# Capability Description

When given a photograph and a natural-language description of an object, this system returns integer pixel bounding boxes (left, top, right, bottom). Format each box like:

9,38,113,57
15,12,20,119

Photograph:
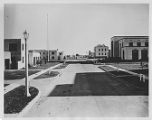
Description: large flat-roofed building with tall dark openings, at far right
111,36,148,60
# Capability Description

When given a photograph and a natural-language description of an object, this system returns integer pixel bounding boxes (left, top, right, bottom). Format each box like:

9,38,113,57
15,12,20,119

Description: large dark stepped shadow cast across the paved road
49,72,148,97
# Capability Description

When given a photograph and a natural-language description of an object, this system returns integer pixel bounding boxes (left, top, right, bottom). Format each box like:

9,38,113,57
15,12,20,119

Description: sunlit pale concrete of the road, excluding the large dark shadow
24,64,148,117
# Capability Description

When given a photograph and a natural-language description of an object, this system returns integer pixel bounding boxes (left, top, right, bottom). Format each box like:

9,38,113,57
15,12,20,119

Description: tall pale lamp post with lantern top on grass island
23,30,31,97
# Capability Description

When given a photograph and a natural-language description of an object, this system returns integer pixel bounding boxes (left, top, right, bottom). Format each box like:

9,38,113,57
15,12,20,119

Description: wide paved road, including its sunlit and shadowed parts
25,64,148,117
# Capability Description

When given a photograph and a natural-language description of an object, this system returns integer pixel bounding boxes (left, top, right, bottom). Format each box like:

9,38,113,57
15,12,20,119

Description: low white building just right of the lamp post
28,50,41,66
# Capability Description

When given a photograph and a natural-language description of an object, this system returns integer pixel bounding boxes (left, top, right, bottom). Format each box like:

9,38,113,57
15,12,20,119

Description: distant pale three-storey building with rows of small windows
94,44,109,58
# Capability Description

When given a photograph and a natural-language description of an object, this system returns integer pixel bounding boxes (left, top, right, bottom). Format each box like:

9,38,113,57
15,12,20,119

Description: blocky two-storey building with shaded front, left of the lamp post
4,39,25,69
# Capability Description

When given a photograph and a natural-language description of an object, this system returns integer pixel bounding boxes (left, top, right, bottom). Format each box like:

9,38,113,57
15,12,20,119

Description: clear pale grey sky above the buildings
4,4,149,55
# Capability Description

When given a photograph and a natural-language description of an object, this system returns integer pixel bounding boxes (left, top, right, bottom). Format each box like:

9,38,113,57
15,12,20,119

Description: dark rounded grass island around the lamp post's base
4,86,38,114
